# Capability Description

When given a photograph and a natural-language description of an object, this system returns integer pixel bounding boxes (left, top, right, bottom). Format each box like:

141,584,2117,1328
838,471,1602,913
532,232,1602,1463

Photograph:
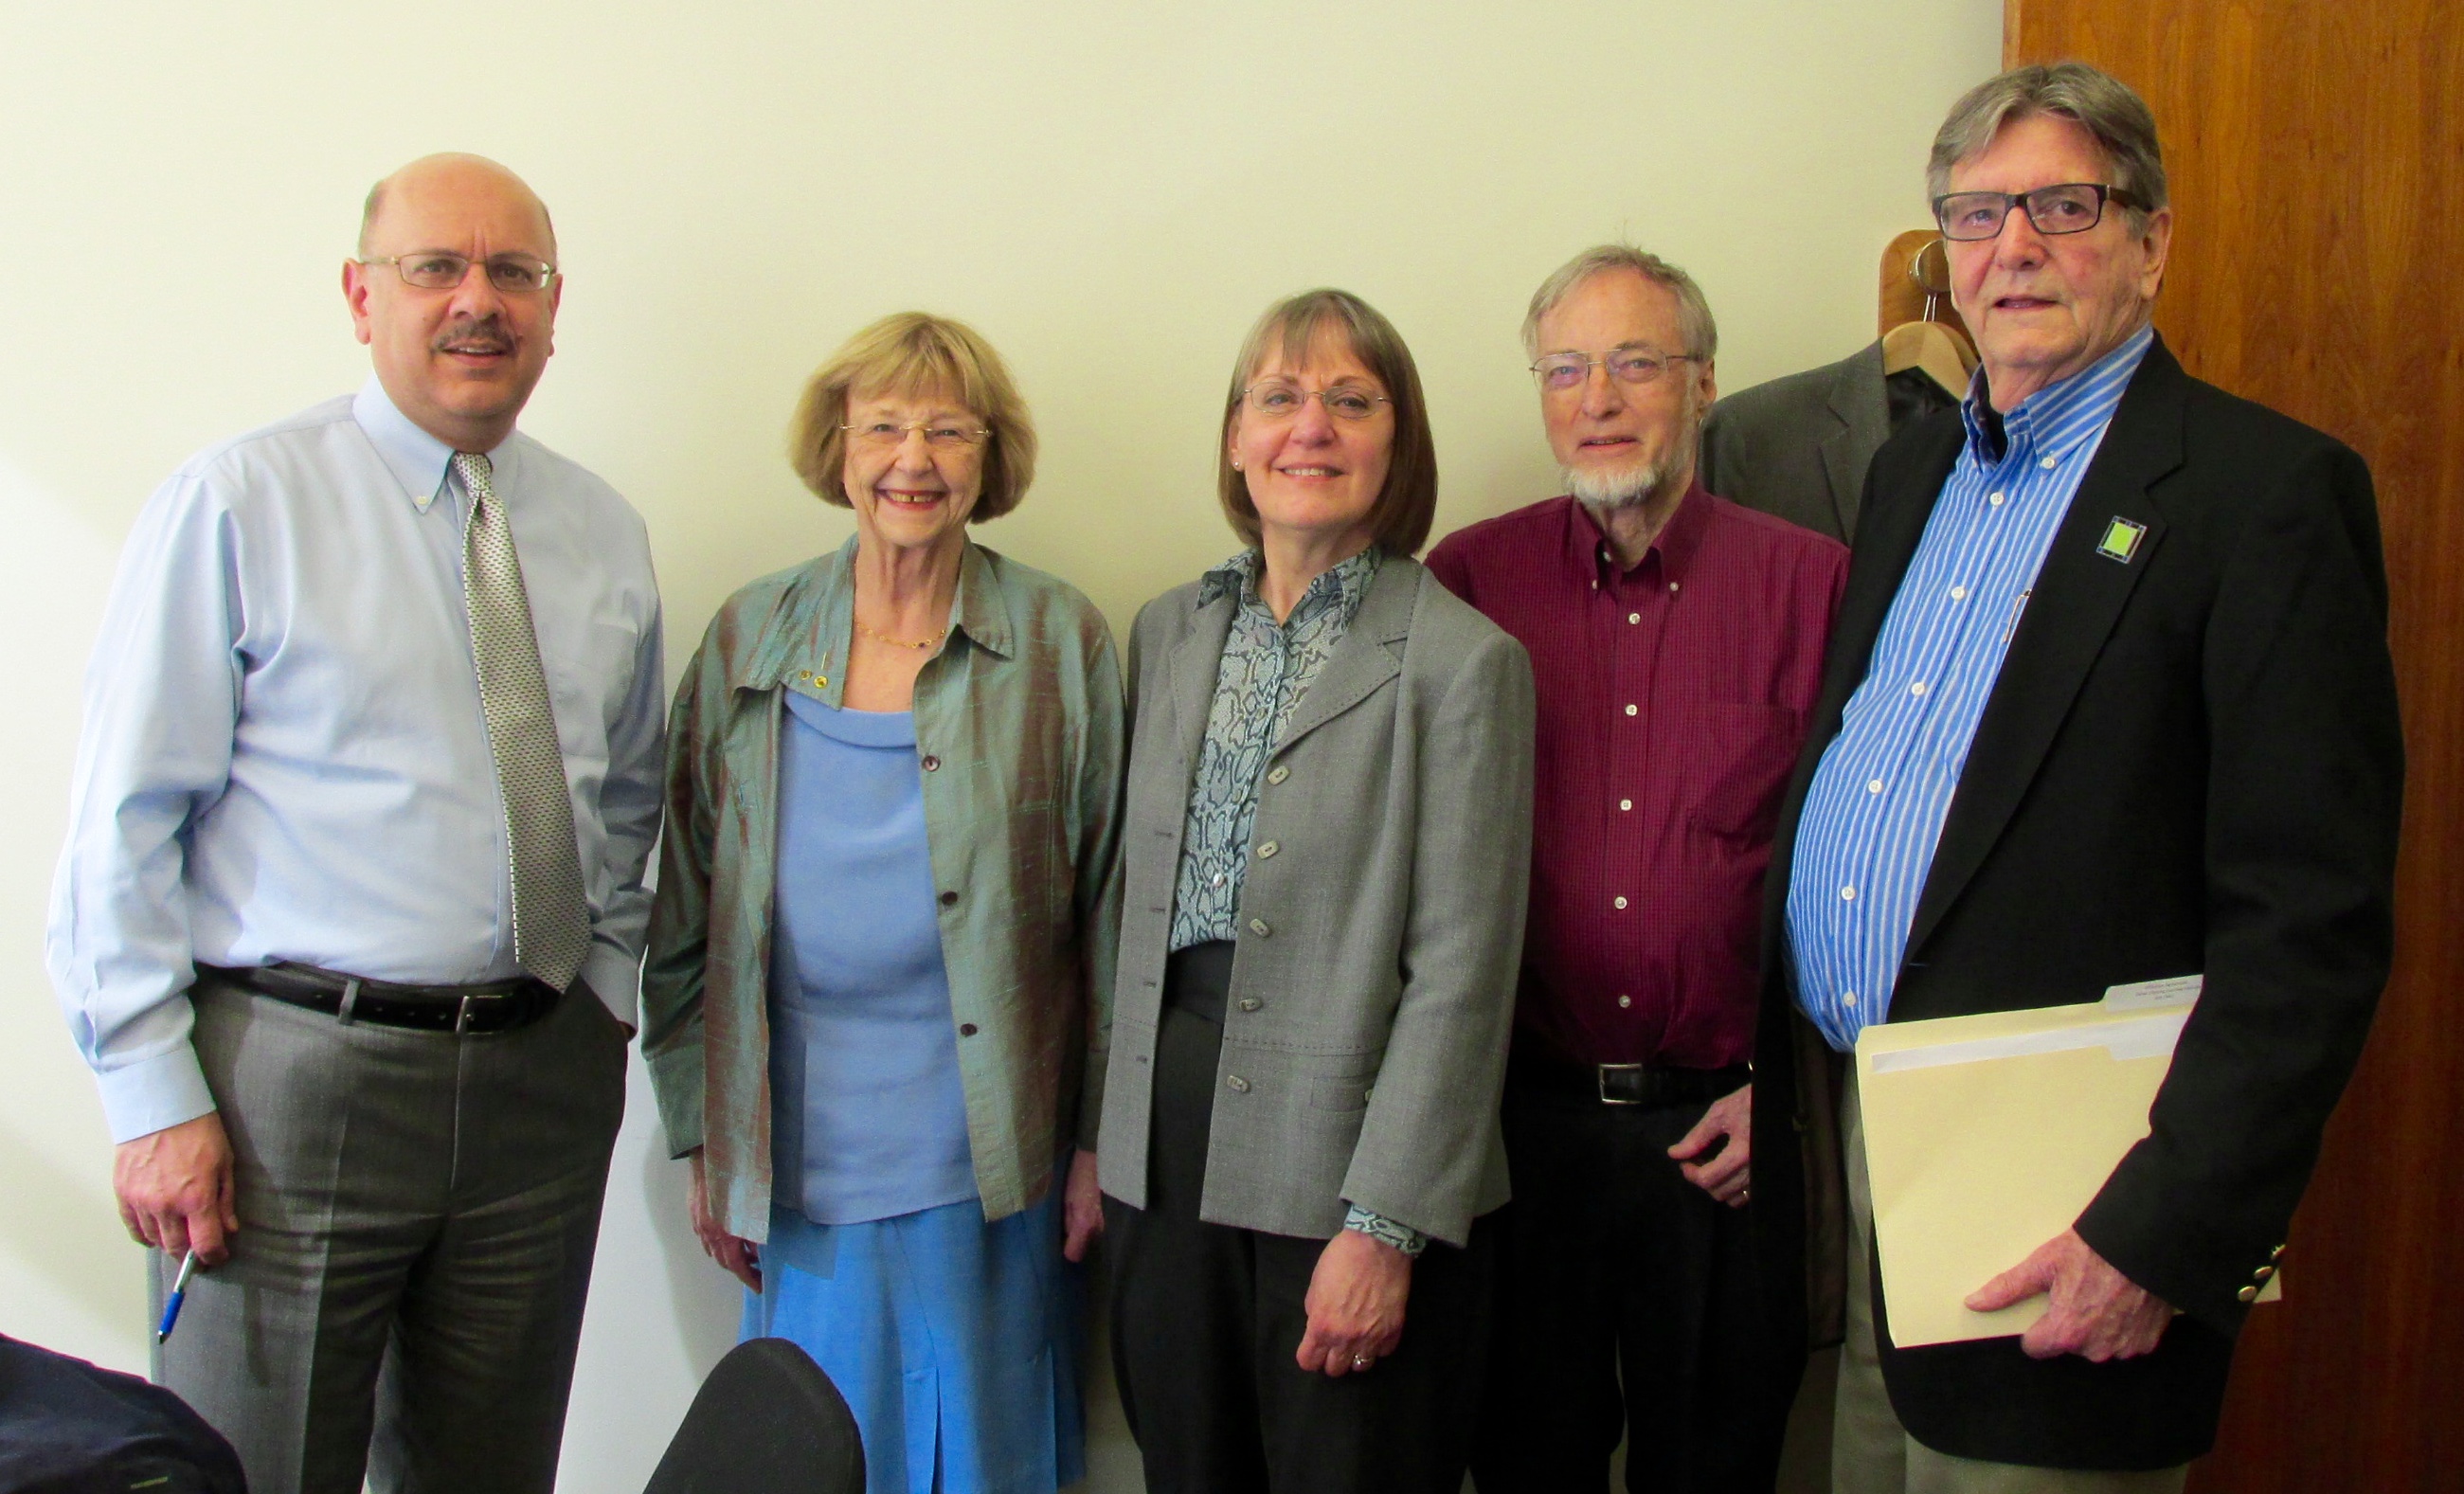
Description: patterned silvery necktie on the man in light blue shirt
454,451,591,991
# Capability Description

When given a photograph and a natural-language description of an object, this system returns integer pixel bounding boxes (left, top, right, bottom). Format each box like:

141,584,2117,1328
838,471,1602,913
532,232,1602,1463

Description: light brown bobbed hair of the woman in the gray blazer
1214,288,1436,555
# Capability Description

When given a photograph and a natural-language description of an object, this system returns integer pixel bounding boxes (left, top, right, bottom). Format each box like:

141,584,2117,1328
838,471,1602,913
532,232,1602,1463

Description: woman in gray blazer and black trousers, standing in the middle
1099,291,1533,1494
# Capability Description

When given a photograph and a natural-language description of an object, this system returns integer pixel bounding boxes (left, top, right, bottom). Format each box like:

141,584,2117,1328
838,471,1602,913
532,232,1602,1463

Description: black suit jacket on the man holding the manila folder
1754,343,2402,1469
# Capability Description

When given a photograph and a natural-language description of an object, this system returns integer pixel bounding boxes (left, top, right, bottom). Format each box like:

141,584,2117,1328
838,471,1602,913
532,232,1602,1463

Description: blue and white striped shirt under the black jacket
1789,328,2153,1053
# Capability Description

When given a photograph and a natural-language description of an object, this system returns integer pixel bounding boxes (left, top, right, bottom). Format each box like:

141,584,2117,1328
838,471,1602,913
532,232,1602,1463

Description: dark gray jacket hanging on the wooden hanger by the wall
1700,340,1890,543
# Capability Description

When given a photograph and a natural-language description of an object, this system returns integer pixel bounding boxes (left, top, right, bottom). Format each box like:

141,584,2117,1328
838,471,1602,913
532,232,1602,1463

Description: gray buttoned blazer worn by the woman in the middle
1099,555,1533,1245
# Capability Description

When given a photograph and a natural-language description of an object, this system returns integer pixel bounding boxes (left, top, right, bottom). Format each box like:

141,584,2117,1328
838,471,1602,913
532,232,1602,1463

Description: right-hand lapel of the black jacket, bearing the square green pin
1907,343,2185,954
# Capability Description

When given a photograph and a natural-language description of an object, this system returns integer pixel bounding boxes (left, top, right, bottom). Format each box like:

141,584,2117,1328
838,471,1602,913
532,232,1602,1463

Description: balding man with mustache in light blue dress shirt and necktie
46,155,663,1494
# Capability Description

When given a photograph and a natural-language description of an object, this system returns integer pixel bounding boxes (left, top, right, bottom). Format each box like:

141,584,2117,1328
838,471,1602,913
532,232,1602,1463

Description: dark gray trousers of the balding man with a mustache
151,977,626,1494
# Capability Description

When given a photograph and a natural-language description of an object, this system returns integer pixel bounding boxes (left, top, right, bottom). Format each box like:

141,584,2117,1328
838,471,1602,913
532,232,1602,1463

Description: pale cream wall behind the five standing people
0,0,2001,1491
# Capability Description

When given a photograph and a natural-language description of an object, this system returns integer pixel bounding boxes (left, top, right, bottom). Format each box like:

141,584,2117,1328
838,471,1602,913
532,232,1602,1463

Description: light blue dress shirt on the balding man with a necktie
45,380,665,1142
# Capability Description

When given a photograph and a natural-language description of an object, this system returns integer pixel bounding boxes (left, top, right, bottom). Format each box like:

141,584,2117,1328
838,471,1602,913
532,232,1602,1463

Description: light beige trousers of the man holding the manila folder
1831,1085,2190,1494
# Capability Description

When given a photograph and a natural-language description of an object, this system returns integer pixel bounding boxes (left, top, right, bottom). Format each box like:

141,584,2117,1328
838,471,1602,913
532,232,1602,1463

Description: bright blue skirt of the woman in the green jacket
742,1181,1087,1494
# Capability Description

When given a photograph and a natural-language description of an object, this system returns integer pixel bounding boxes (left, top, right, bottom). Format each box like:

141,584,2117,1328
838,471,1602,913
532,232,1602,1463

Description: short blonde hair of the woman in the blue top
786,311,1034,523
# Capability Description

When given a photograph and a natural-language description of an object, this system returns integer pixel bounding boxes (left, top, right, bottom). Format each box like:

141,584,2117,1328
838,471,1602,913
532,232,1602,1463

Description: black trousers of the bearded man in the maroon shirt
1471,1070,1804,1494
